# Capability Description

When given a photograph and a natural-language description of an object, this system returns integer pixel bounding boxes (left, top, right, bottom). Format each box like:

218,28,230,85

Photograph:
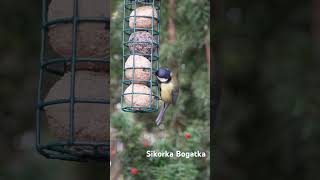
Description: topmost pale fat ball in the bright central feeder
129,6,158,29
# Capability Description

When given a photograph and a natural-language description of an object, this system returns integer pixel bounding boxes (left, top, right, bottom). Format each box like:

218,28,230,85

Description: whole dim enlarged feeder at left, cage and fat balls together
36,0,110,162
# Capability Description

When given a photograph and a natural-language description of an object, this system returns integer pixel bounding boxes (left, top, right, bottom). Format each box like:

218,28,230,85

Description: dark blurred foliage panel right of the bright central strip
213,0,320,180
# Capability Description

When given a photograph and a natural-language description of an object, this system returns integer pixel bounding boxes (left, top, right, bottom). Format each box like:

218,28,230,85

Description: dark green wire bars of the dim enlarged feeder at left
36,0,110,162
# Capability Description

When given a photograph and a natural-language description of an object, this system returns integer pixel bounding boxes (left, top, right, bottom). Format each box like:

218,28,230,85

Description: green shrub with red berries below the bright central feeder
111,112,210,180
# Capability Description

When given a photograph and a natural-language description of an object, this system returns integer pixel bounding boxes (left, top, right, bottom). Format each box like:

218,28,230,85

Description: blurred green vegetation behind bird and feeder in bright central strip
111,0,210,180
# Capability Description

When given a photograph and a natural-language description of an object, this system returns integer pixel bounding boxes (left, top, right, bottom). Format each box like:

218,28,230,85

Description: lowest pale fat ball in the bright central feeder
124,84,153,110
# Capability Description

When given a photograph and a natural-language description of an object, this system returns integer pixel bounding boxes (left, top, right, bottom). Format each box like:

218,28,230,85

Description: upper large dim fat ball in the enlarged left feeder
48,0,109,57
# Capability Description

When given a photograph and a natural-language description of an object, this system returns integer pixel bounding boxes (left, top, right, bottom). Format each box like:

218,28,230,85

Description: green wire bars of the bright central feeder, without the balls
121,0,161,113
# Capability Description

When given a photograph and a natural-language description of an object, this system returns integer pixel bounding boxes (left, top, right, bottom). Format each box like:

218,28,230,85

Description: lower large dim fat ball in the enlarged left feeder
45,71,109,142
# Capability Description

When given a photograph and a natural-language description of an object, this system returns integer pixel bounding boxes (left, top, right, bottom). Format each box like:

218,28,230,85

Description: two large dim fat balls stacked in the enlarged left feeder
45,0,110,153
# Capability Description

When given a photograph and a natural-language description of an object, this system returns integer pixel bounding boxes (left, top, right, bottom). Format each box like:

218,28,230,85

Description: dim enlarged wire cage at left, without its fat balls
36,0,110,162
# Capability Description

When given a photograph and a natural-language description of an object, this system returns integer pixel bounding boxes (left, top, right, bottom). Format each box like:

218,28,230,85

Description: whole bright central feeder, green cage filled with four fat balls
121,0,160,112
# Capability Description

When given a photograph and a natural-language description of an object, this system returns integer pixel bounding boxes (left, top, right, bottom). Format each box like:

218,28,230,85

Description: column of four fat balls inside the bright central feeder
124,5,159,111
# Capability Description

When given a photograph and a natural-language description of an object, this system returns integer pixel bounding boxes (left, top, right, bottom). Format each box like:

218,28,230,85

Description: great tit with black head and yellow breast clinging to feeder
154,68,179,126
